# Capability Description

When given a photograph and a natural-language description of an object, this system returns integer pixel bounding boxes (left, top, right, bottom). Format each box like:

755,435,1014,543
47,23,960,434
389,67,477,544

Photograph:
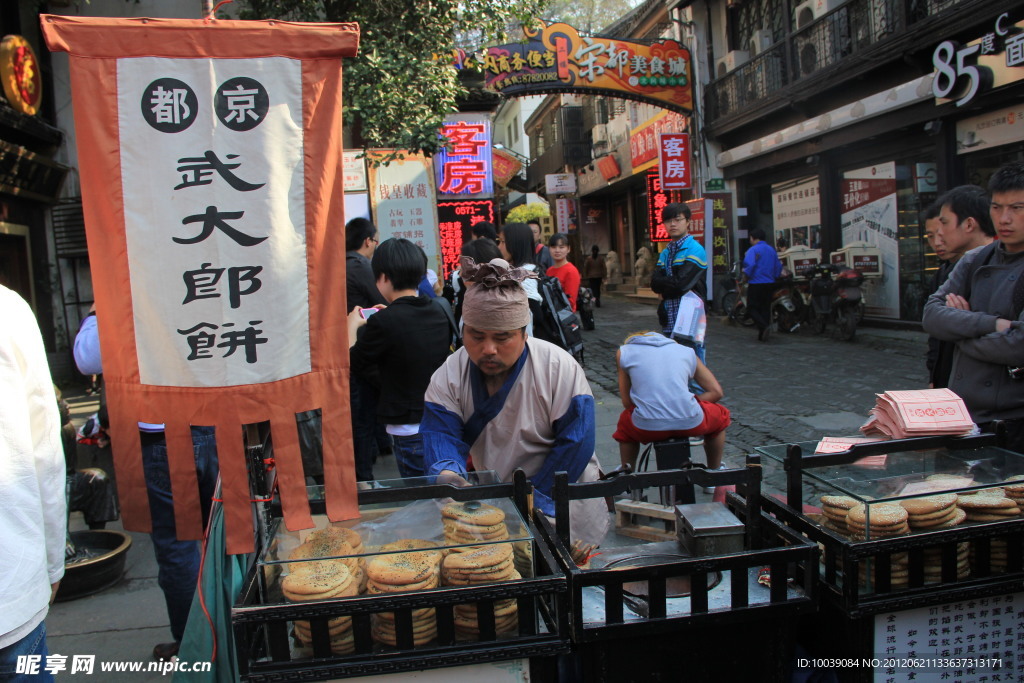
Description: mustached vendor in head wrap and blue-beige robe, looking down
420,258,608,543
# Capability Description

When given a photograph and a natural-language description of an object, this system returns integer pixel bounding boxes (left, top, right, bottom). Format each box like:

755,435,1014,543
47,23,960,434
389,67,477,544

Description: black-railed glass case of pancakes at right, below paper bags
752,435,1024,614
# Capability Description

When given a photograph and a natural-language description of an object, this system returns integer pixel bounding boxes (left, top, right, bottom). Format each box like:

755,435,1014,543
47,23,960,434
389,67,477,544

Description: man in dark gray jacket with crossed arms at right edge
923,162,1024,453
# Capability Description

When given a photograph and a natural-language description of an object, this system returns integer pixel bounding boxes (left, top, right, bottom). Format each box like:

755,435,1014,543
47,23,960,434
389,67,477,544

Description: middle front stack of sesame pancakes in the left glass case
367,539,441,647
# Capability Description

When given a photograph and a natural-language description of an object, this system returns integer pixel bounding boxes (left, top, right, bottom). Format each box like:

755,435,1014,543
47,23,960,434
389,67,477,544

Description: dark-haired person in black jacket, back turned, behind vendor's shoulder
348,239,454,477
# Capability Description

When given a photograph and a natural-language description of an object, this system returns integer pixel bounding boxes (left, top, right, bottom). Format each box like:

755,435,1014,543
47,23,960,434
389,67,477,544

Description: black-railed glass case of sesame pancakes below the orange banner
232,472,567,680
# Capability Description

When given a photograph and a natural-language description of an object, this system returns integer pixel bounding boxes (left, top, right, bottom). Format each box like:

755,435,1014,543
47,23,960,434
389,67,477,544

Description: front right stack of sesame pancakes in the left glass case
441,543,521,640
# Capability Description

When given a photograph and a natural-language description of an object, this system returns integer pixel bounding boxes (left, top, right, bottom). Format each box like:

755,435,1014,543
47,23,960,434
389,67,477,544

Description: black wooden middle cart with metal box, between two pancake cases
537,466,817,683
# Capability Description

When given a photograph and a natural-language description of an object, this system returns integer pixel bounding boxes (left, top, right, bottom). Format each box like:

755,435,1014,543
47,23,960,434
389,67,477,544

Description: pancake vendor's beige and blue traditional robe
420,338,608,543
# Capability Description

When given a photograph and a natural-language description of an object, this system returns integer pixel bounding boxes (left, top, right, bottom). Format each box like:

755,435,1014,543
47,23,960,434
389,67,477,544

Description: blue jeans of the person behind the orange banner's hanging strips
142,427,217,642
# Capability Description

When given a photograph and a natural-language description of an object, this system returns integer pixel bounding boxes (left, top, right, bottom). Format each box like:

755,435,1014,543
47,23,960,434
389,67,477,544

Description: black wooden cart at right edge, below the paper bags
748,434,1024,681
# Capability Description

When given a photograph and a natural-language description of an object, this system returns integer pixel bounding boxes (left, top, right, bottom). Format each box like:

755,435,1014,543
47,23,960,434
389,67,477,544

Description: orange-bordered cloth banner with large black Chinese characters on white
41,14,359,554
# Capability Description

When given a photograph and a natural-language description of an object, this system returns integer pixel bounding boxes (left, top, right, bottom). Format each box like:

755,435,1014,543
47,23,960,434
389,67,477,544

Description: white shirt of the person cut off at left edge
0,286,68,648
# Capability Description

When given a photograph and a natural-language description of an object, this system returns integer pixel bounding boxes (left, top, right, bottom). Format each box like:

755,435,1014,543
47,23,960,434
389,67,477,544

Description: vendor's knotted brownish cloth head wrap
462,256,537,332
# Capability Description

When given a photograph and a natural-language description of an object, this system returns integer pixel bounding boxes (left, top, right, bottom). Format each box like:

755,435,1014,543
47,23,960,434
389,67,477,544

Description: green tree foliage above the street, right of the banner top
242,0,545,160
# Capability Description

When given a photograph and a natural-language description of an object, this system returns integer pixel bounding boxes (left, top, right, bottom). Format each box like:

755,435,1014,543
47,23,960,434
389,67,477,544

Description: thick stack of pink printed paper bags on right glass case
860,389,975,438
